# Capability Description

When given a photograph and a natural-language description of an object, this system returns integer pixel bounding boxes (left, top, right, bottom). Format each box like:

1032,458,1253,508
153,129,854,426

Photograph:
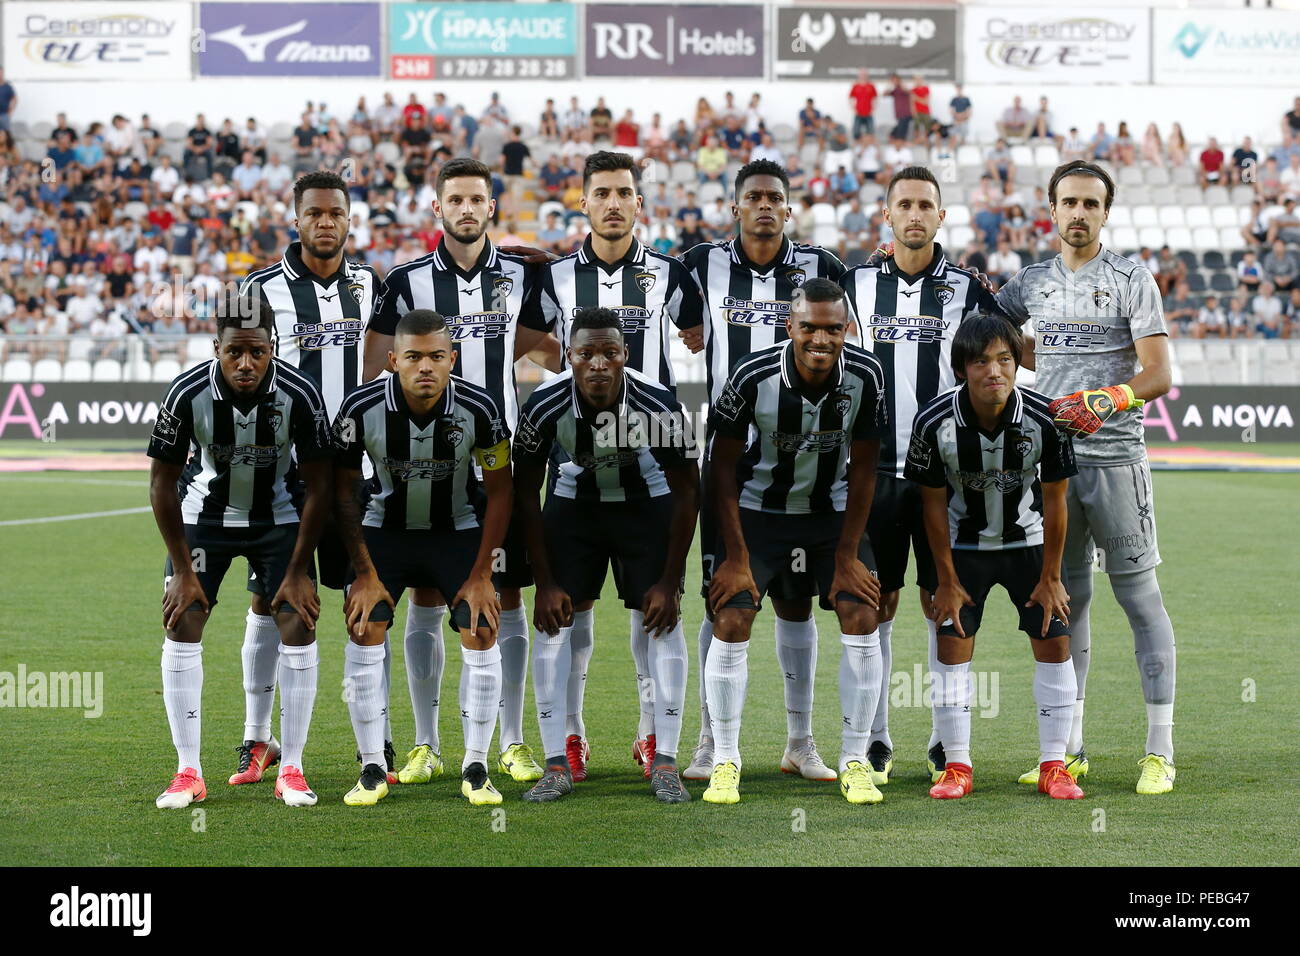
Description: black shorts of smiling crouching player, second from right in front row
718,509,876,610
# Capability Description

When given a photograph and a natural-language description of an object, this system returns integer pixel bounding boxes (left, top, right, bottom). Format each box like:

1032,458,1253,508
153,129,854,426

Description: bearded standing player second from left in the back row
365,157,560,783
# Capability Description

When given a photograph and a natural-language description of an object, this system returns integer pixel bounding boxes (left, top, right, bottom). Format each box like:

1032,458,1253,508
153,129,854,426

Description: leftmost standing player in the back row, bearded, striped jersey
230,170,397,784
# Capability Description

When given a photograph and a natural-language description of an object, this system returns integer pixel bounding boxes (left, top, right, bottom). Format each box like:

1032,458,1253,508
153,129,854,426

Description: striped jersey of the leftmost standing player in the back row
239,242,378,416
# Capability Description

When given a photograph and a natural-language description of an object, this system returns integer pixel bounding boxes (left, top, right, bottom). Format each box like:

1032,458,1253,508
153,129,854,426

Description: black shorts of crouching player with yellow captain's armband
347,527,488,630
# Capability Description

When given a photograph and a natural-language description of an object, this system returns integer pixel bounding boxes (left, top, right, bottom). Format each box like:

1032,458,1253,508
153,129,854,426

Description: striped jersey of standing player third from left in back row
524,235,705,388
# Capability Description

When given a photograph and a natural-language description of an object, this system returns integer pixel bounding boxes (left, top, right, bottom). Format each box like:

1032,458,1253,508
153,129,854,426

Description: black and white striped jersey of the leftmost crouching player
148,359,334,528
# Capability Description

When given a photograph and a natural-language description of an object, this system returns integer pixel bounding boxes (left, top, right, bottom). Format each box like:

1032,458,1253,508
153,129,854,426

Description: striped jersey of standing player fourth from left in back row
683,237,861,402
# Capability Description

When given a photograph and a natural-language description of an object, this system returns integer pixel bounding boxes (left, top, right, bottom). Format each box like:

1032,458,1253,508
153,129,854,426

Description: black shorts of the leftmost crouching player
163,524,316,614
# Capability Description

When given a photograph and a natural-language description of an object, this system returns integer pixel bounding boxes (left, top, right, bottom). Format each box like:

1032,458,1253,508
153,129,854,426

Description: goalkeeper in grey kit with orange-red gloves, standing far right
997,160,1175,793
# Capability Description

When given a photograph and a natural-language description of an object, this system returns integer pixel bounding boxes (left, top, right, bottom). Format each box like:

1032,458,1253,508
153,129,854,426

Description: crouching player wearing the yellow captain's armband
334,310,512,806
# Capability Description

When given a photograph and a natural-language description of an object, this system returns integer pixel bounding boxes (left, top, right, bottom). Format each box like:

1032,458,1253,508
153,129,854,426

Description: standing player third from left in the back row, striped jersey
524,150,703,780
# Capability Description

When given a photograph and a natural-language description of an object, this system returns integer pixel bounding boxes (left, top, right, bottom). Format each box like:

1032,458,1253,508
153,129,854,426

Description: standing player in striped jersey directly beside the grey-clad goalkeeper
840,166,997,787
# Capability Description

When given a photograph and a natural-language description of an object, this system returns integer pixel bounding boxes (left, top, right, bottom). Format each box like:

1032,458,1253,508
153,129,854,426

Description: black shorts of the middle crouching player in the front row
542,494,684,611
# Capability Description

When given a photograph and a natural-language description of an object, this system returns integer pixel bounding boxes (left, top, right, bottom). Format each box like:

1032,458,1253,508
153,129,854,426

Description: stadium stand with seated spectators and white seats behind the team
0,85,1300,384
